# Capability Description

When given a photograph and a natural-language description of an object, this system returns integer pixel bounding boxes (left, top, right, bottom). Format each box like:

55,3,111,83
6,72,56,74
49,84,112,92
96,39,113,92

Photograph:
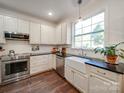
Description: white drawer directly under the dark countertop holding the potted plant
89,66,119,81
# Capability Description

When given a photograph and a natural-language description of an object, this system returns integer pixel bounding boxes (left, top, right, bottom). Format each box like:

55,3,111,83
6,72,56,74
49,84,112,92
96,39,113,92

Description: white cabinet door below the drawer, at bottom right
89,74,118,93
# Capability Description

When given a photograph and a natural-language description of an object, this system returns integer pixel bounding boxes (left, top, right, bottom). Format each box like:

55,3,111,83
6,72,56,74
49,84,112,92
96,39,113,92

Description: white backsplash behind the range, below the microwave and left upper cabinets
2,40,53,55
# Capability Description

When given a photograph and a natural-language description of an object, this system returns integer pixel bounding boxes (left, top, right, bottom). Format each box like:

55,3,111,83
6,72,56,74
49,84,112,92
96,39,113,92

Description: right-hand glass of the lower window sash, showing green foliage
91,32,104,48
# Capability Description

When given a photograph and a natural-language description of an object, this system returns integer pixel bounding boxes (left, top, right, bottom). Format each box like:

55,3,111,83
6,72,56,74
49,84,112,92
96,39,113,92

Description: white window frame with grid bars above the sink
71,11,106,50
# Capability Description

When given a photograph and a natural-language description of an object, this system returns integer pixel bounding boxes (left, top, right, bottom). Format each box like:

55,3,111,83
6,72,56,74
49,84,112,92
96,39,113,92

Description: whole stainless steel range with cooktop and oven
1,55,30,84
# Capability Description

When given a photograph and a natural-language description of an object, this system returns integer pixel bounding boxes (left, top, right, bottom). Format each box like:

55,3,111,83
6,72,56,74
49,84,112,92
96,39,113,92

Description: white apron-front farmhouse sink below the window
65,56,89,73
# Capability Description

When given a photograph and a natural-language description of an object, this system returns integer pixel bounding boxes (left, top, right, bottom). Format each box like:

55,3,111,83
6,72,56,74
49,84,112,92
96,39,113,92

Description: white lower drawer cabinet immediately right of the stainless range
30,55,52,75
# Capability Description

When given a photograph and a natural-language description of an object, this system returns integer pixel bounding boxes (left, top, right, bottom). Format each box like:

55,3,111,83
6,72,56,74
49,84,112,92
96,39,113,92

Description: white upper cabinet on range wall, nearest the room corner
41,25,56,44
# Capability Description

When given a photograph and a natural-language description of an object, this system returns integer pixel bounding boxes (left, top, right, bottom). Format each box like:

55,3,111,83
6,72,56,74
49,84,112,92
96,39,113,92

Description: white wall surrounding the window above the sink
63,0,124,62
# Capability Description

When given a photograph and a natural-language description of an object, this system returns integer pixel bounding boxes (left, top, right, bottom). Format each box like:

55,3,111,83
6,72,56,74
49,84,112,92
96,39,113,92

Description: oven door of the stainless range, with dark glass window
2,59,29,81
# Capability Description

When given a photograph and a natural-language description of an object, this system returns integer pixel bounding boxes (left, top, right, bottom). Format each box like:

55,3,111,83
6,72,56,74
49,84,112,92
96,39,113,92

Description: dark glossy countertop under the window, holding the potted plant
68,54,124,74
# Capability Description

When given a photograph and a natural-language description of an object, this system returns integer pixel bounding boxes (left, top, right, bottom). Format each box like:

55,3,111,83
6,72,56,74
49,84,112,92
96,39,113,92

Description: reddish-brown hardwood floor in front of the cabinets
0,71,80,93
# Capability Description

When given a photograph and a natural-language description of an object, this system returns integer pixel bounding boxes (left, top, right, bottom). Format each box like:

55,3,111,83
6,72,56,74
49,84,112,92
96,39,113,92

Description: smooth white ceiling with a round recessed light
0,0,88,23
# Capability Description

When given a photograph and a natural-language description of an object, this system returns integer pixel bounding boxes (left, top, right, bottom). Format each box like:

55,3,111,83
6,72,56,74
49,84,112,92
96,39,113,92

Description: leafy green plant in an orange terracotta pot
94,42,124,64
